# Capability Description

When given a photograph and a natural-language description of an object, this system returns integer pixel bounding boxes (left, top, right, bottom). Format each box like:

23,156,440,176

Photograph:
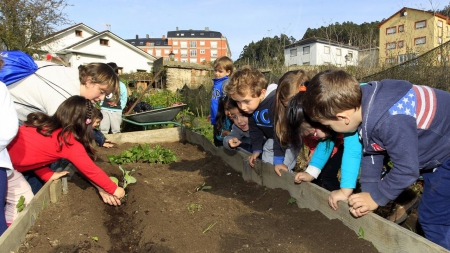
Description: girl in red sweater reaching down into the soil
8,96,125,205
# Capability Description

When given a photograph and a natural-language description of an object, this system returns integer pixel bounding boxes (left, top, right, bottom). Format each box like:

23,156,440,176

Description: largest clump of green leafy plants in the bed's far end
108,144,178,165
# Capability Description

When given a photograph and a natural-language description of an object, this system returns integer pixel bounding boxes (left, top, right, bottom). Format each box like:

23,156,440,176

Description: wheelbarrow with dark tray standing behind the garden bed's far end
122,104,187,130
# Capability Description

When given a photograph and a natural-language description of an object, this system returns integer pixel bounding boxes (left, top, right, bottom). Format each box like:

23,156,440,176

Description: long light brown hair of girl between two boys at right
274,69,310,146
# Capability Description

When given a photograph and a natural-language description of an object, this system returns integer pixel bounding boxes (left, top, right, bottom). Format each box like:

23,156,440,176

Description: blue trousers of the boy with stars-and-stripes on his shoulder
419,159,450,250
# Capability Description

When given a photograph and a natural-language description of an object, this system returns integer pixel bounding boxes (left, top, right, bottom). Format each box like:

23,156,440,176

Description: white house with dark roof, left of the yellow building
284,38,358,67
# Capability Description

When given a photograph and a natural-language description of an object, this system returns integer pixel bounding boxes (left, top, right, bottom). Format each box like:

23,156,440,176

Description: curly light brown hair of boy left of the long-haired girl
225,65,267,97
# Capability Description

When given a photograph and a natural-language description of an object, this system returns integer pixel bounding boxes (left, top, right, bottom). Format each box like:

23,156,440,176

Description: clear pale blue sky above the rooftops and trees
58,0,450,60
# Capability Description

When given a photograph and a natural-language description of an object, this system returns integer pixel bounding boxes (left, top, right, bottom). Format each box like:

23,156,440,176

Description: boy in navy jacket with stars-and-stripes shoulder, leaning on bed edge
303,70,450,249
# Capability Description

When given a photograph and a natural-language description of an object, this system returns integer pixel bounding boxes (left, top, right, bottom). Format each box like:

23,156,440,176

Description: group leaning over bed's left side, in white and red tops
0,58,125,235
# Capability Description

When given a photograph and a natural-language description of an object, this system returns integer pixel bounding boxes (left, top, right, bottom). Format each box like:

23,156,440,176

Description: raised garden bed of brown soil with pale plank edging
0,128,446,253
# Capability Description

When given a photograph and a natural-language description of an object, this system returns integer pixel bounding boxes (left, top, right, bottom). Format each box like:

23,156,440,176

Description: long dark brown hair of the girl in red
24,96,95,157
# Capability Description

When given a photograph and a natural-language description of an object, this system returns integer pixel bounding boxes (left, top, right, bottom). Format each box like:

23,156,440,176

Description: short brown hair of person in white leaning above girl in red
78,62,120,102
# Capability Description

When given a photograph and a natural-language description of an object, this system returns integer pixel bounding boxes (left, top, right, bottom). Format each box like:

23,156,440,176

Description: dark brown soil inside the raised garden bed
19,143,377,253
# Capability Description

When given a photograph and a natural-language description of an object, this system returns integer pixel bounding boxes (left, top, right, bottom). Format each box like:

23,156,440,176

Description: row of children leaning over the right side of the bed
212,58,450,249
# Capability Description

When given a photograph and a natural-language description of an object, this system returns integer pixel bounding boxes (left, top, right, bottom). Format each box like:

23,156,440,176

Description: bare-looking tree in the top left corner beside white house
0,0,71,54
